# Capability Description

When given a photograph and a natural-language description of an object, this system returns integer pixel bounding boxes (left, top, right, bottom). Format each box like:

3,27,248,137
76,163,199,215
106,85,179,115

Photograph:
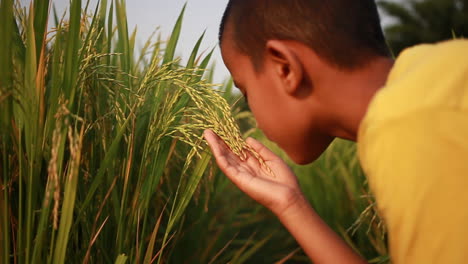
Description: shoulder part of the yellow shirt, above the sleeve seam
364,40,468,129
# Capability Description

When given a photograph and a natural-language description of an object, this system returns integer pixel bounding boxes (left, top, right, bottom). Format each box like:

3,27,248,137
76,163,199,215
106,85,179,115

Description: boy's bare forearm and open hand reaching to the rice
205,131,366,263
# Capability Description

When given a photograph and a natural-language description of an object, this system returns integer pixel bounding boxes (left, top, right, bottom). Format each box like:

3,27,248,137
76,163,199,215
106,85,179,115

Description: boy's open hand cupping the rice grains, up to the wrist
204,130,304,216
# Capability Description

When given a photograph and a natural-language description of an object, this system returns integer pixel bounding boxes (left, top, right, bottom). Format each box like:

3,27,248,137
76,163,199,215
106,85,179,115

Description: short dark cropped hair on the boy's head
219,0,390,70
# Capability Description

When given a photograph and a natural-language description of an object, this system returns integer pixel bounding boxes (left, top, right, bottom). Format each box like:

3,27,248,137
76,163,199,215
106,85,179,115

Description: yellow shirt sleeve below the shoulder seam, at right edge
360,109,468,264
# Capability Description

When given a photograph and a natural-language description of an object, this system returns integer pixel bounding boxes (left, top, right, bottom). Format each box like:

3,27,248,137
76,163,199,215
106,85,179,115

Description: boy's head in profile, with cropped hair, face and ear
219,0,389,163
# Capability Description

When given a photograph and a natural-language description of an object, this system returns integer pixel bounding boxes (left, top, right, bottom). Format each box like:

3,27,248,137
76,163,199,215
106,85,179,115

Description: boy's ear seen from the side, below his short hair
266,40,304,94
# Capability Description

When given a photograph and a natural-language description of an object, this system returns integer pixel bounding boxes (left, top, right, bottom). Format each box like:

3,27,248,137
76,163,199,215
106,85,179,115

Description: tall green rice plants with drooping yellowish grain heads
0,0,385,263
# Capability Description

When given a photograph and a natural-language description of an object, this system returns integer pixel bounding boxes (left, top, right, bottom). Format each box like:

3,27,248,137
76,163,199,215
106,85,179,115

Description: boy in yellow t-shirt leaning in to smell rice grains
205,0,468,263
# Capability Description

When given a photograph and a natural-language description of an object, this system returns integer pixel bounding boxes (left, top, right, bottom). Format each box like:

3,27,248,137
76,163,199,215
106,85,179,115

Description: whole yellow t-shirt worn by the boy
358,40,468,264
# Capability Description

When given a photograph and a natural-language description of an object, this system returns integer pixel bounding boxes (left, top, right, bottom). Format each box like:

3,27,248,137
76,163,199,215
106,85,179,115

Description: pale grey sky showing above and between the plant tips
20,0,396,83
